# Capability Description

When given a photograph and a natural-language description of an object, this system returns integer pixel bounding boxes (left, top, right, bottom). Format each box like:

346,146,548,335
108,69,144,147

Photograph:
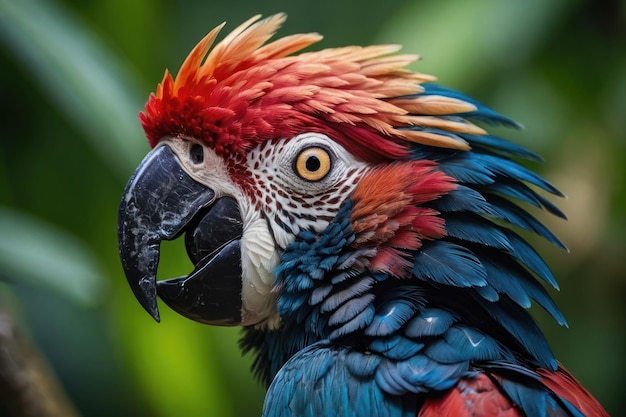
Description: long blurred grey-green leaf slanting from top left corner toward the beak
0,0,147,178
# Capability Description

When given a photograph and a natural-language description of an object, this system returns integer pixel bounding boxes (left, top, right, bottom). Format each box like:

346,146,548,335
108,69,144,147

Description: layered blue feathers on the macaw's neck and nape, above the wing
241,85,565,393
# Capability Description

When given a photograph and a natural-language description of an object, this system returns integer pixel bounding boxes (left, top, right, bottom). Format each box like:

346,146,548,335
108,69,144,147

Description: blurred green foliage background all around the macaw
0,0,626,417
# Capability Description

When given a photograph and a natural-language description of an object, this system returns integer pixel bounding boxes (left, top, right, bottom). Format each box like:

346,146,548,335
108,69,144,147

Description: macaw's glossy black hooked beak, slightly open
118,145,243,325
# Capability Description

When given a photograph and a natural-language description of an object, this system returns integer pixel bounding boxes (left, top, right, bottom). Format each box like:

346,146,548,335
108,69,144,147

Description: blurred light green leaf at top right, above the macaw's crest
378,0,567,89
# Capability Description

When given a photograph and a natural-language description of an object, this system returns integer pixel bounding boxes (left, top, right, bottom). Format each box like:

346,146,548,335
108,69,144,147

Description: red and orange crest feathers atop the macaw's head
139,14,482,160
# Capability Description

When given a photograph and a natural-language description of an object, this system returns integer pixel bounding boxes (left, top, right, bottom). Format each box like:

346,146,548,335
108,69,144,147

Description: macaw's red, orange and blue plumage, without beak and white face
135,14,605,417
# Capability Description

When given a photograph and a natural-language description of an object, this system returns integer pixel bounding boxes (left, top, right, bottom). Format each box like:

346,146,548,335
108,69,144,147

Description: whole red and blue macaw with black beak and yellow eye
118,14,608,417
